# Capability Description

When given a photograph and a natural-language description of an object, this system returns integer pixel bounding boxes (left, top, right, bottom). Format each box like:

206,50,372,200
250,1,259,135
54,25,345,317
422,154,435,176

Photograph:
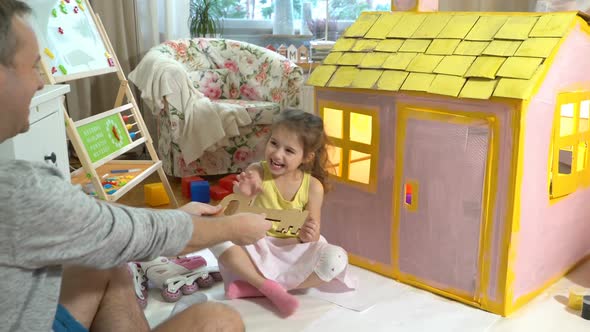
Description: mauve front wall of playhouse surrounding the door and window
317,91,512,300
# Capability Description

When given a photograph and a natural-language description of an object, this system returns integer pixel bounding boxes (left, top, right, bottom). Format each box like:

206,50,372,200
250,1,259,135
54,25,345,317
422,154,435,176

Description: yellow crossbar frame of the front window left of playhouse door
318,101,379,193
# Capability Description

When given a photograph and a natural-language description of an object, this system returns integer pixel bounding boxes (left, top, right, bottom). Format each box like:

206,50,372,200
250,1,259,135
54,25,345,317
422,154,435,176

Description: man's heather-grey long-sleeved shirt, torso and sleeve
0,161,193,331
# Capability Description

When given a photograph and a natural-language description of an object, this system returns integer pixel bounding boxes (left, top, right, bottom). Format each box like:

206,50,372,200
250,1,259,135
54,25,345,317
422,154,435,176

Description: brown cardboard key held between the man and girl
219,194,309,236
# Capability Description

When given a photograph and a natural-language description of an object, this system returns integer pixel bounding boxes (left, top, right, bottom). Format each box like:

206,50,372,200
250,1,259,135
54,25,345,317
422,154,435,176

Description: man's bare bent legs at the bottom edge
60,266,244,332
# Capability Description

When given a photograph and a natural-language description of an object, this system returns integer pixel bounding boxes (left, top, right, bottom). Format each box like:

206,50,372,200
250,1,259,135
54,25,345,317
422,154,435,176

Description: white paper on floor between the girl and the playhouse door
305,266,411,311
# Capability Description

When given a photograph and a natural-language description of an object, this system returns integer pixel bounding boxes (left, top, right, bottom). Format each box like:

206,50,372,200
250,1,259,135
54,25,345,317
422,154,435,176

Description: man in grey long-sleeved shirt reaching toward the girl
0,0,271,331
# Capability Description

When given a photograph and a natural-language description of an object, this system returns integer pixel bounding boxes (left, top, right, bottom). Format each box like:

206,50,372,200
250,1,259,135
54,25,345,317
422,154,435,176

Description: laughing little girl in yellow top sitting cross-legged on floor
211,110,354,316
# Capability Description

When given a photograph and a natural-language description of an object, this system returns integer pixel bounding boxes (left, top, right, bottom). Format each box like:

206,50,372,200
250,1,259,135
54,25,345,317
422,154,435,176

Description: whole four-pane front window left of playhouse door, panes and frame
320,107,378,188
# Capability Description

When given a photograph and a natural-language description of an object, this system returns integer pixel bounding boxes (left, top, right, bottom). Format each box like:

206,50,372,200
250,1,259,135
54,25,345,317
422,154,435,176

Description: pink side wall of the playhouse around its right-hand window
513,27,590,300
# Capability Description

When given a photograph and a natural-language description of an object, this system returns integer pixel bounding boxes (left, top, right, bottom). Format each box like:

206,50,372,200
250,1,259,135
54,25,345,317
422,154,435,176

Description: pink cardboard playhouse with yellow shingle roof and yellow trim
308,12,590,315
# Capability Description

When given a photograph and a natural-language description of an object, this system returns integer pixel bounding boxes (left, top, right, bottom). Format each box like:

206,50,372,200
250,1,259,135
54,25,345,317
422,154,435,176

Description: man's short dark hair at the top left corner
0,0,31,66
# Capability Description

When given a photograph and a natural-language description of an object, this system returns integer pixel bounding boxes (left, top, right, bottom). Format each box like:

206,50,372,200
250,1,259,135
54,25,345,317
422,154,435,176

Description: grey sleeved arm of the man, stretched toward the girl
0,162,193,268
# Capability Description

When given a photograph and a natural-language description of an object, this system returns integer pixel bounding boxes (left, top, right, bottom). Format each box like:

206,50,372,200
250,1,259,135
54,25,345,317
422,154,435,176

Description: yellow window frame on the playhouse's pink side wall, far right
549,91,590,198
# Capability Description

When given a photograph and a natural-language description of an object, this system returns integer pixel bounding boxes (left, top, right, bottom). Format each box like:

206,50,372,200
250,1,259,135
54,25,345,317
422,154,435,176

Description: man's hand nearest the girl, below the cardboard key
225,213,272,246
